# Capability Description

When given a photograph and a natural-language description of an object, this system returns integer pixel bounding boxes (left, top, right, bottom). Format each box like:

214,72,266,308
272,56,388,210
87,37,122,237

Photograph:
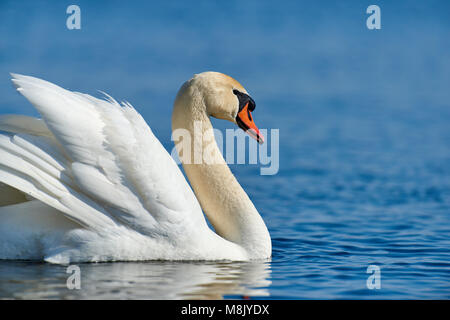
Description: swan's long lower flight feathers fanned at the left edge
0,133,118,230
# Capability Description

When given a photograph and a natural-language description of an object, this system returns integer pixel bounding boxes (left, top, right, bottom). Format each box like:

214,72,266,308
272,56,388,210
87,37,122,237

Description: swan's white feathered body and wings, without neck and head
0,74,270,263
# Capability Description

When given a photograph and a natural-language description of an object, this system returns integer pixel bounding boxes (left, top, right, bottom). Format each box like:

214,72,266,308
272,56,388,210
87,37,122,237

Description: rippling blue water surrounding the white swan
0,1,450,299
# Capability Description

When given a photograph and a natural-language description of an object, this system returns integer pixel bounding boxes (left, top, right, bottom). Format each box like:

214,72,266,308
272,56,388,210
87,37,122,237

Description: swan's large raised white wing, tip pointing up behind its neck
6,74,206,240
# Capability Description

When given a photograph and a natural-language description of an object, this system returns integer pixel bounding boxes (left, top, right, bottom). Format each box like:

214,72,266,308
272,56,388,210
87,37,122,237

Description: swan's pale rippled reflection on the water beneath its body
0,261,271,299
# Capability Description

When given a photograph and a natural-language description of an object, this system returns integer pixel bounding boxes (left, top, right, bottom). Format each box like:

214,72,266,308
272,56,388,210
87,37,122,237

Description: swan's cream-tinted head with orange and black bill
190,71,264,144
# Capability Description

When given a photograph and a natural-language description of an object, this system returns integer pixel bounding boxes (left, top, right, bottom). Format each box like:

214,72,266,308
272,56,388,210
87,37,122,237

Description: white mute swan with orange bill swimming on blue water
0,72,272,264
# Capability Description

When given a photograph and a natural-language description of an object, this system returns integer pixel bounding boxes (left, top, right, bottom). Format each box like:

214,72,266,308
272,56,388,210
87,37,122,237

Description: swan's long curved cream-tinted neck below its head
172,85,272,259
